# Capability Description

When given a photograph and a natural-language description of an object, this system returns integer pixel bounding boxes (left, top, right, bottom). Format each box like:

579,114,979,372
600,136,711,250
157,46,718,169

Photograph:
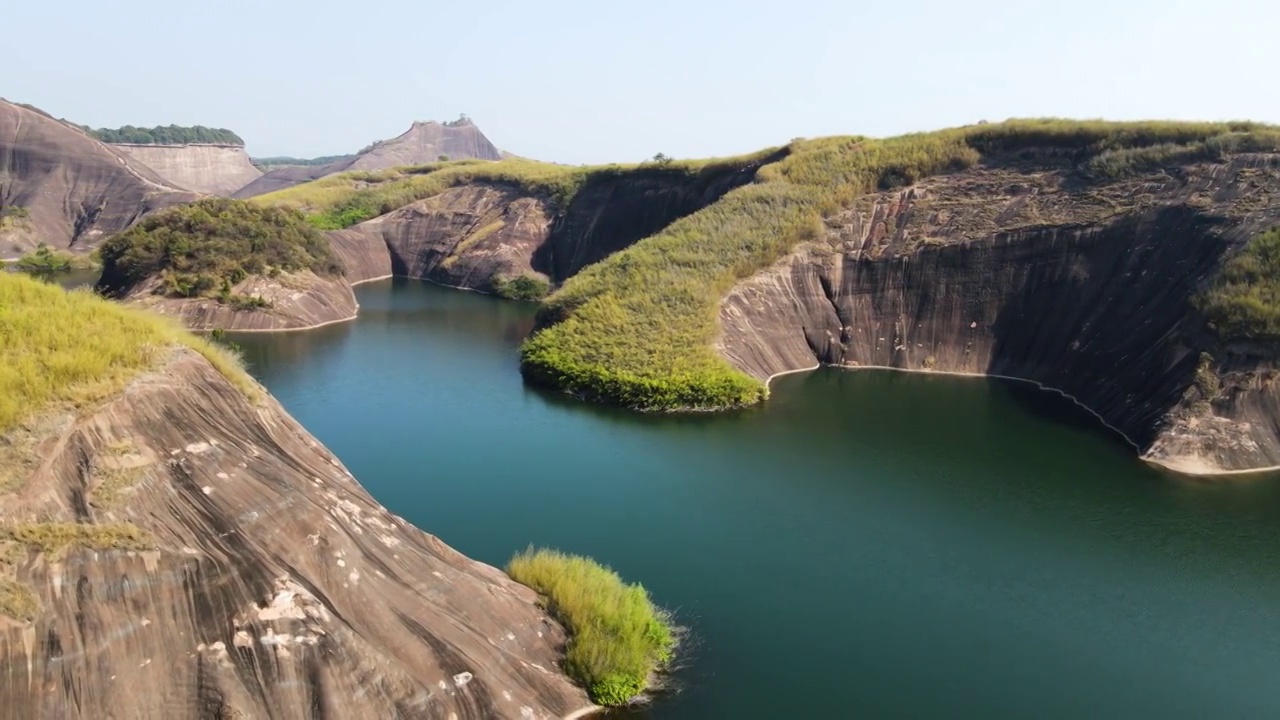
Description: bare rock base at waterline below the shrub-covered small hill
123,270,360,331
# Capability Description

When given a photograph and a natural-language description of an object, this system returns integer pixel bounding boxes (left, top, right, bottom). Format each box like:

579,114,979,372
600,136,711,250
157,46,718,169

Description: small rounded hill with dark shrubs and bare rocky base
97,199,356,329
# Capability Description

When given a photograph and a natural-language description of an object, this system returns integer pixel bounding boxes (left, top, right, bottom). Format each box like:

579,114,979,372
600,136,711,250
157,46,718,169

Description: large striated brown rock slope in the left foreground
0,350,589,720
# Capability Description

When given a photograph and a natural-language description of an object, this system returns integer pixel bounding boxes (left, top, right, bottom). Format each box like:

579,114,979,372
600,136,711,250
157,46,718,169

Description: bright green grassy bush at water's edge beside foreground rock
507,548,675,706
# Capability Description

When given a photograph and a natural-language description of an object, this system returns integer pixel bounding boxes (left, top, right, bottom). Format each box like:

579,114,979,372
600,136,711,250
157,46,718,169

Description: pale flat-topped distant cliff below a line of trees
111,145,262,197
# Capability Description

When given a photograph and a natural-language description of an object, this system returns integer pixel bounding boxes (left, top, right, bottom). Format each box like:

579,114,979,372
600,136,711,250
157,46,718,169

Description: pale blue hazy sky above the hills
10,0,1280,163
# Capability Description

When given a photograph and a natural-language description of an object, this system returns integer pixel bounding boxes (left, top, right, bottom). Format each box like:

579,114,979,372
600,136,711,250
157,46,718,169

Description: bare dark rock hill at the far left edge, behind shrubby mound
0,100,196,258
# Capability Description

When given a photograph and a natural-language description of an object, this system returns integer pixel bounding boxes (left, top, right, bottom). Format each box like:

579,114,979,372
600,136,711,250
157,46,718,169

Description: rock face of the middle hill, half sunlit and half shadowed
329,158,776,292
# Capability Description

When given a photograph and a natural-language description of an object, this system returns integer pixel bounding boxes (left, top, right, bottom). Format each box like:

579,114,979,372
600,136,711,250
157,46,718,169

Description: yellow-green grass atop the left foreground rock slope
0,273,257,433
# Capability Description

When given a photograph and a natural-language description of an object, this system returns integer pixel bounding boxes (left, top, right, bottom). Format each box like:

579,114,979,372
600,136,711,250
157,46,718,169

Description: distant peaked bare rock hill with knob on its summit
234,120,502,197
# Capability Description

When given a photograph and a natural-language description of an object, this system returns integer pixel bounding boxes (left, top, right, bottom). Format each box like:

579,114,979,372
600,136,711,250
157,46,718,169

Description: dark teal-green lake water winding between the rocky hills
236,281,1280,720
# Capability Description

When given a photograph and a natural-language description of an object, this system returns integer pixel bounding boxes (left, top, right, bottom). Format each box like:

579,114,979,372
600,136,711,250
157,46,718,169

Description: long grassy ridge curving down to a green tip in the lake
521,119,1280,410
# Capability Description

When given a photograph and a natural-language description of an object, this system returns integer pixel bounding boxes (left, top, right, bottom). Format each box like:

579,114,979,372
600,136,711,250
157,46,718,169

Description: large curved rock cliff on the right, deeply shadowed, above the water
721,155,1280,474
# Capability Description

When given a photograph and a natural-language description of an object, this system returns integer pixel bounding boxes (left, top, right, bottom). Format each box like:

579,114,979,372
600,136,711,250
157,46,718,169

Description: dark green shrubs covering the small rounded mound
99,197,342,299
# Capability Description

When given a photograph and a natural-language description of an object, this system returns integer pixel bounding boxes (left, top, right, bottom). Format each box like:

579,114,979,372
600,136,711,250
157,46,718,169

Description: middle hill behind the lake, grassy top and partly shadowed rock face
255,151,781,300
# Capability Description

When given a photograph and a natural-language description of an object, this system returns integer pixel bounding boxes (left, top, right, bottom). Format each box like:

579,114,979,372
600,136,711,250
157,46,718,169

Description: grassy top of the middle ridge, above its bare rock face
253,150,777,229
